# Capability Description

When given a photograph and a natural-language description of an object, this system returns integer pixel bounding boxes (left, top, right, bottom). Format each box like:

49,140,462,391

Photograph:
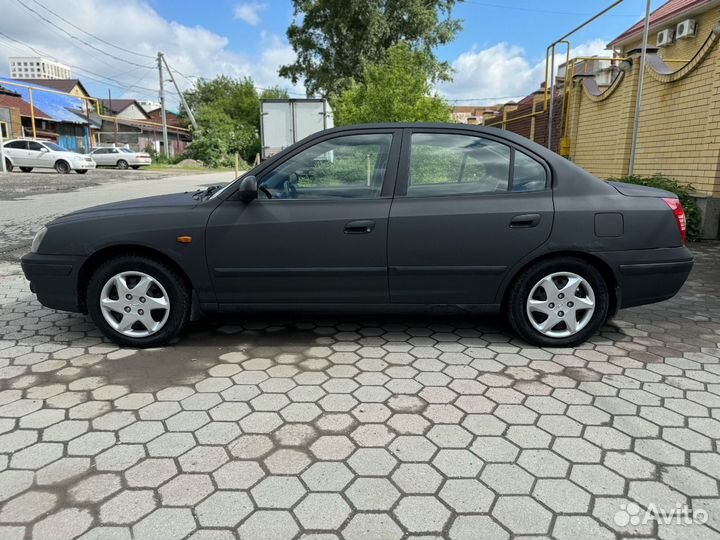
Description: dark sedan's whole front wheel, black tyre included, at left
86,255,191,348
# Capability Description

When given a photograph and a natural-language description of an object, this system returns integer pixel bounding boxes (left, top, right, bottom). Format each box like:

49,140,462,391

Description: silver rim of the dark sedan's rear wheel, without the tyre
526,272,595,338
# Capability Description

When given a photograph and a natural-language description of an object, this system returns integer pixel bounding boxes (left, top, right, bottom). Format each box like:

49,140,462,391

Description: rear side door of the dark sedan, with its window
388,129,553,304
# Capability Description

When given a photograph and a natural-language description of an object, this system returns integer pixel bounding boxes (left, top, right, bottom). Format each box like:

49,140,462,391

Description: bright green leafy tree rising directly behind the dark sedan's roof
333,43,450,125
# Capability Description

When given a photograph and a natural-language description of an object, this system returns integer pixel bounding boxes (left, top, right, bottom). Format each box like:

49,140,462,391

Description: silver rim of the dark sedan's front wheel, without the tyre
100,271,170,338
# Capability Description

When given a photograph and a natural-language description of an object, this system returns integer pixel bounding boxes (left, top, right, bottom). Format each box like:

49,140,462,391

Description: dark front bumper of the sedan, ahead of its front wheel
21,253,85,313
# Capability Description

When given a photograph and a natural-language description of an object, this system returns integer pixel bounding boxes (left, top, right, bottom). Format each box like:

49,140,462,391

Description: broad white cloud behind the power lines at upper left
0,0,304,107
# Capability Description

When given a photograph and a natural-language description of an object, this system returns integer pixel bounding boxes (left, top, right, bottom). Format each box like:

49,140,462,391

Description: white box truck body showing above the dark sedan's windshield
260,98,334,159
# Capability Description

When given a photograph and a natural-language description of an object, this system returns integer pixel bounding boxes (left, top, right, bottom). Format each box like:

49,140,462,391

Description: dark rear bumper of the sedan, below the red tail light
595,246,693,308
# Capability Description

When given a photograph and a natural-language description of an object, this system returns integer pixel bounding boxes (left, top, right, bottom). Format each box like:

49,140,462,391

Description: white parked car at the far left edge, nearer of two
3,139,95,174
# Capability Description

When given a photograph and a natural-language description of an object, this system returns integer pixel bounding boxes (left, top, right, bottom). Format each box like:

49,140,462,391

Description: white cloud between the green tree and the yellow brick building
438,39,608,105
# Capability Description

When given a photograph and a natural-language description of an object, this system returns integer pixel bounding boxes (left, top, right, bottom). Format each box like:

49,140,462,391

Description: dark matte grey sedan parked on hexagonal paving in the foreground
22,124,693,347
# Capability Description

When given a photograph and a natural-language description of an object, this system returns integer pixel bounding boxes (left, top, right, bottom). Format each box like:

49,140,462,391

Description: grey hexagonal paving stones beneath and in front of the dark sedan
0,175,720,540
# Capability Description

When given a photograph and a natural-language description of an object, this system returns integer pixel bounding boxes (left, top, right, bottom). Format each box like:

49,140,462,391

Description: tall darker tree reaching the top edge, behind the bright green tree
280,0,462,97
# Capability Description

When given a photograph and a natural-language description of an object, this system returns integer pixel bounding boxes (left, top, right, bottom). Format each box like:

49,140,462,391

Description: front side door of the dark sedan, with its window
206,129,401,308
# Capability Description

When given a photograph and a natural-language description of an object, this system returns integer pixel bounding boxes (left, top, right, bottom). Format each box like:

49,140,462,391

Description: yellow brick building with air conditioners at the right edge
484,0,720,238
